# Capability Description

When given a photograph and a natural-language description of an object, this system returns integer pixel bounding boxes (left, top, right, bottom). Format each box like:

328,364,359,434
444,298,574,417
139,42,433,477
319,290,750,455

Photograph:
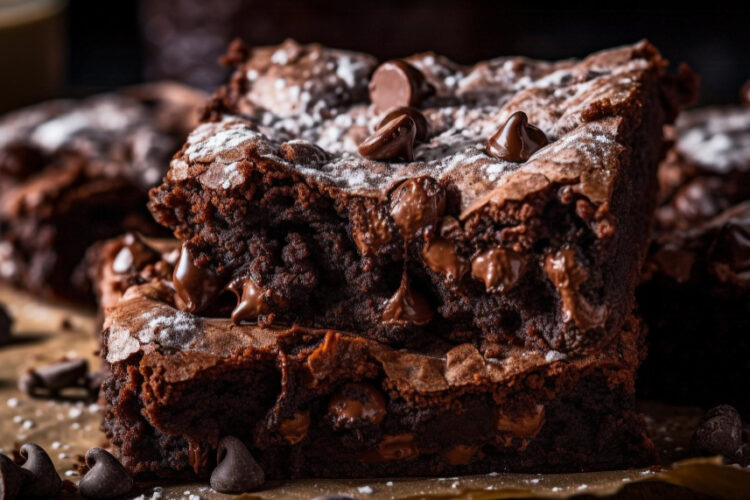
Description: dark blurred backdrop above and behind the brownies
1,0,750,112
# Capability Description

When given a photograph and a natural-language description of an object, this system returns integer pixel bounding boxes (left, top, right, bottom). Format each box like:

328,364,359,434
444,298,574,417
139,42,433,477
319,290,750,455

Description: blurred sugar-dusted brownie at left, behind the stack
0,83,204,302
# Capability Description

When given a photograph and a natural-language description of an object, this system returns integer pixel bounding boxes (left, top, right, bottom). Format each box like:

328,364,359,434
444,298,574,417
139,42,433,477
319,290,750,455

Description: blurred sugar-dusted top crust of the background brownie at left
0,84,203,195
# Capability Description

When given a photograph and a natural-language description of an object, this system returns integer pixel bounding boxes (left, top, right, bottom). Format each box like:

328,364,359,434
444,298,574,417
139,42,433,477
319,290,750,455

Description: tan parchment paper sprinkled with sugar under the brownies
0,287,750,500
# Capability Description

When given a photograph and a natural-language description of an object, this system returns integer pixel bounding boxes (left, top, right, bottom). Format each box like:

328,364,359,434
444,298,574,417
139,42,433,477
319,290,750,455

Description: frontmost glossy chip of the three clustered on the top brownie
357,115,417,161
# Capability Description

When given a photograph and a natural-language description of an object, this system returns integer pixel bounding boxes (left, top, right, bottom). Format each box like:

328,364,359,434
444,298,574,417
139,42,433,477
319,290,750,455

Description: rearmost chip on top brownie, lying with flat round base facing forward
369,59,435,111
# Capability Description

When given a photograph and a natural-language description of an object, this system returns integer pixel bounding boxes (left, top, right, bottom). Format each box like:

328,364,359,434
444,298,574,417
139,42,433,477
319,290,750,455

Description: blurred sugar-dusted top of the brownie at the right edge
675,106,750,174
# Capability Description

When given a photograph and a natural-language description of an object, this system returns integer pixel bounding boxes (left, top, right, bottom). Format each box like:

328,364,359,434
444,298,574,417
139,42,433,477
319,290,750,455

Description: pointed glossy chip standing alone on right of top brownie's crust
487,111,549,163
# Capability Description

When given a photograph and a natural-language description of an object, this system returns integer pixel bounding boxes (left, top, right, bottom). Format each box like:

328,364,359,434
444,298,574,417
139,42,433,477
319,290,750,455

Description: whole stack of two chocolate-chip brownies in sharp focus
97,41,695,477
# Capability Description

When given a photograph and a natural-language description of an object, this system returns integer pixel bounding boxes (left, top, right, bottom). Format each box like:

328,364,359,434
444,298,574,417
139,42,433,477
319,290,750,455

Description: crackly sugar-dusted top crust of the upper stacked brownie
169,41,685,218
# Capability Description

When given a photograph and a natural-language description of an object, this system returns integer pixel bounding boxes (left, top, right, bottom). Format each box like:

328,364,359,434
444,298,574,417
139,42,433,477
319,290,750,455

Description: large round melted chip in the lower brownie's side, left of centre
328,382,386,429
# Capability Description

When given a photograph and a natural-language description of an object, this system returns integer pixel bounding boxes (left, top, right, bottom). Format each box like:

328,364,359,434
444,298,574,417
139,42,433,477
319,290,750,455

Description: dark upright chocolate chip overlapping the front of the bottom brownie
210,436,266,493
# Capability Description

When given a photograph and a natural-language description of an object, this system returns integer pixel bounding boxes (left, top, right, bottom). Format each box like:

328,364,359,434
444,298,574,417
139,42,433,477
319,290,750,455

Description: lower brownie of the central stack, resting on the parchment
102,279,655,478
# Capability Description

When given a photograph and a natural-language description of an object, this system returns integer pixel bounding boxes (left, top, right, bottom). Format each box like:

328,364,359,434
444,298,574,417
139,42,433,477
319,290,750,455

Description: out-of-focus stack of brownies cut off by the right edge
638,100,750,416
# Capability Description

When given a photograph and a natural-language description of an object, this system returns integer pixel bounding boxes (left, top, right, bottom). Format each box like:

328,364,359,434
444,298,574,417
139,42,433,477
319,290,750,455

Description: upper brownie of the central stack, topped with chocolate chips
150,41,695,356
